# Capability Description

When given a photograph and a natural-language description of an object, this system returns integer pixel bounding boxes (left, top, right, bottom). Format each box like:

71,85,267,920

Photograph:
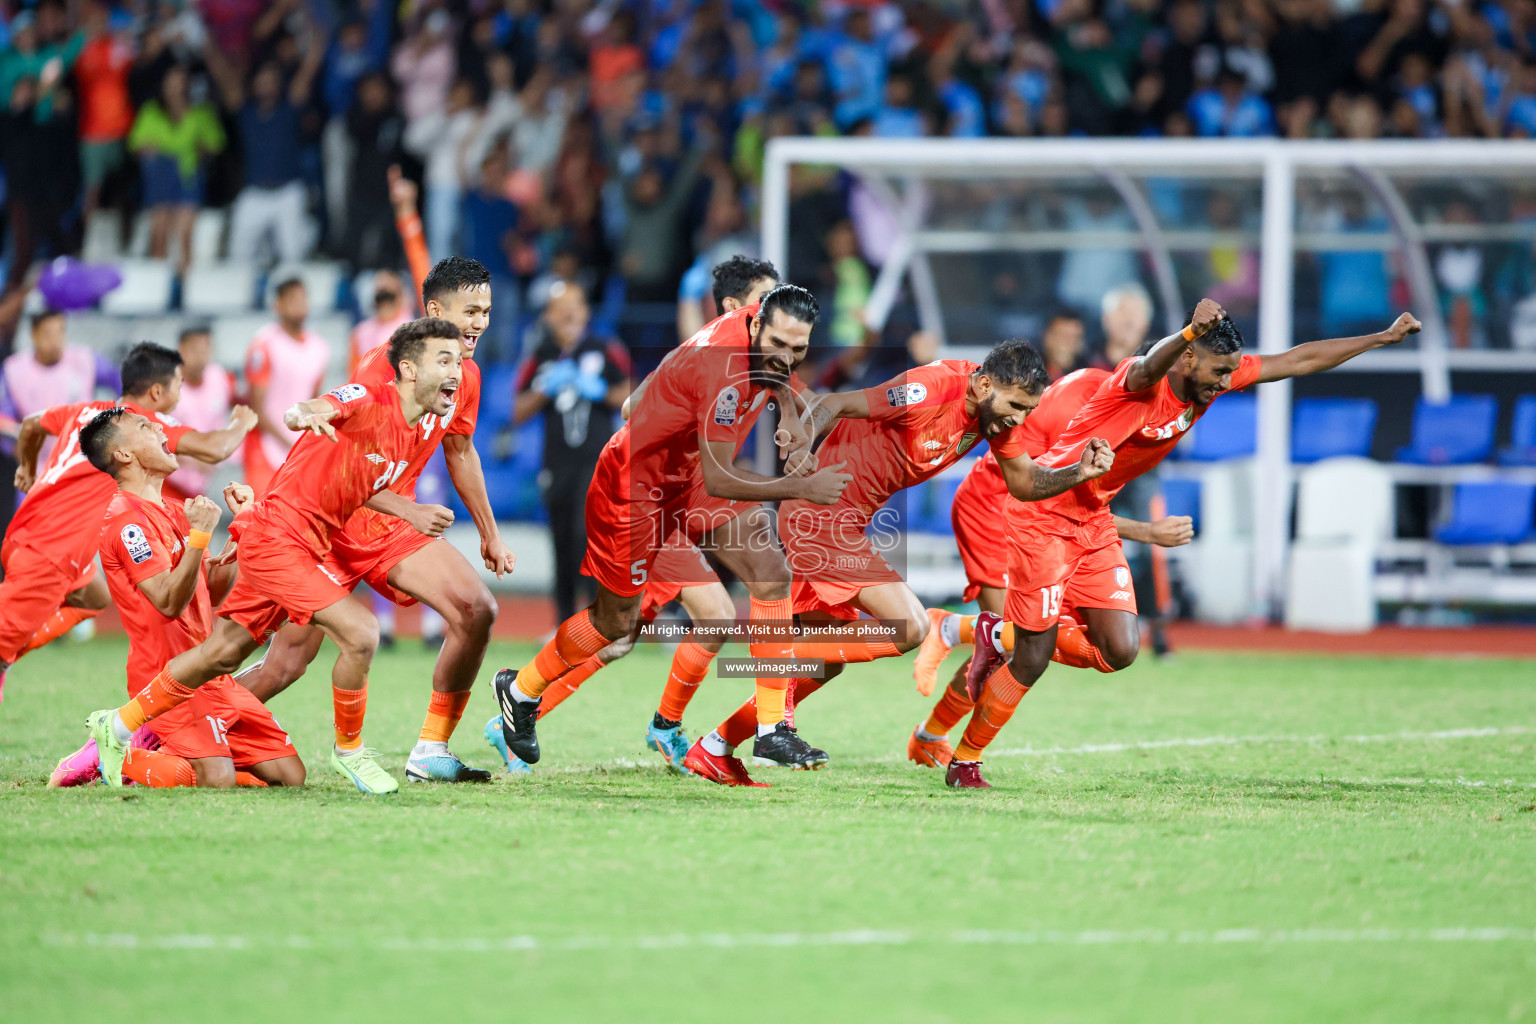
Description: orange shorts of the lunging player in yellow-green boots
218,519,352,643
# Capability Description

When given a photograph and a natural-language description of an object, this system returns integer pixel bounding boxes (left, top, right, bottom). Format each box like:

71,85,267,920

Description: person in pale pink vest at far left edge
0,309,118,468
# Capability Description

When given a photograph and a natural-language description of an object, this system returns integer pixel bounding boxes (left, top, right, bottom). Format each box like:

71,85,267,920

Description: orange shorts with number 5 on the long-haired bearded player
581,453,757,597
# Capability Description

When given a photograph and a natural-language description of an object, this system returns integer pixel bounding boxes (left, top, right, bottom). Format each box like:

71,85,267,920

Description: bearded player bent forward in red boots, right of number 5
685,341,1111,785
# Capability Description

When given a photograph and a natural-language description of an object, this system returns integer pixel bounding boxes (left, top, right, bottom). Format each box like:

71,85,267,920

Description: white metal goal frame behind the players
762,137,1536,619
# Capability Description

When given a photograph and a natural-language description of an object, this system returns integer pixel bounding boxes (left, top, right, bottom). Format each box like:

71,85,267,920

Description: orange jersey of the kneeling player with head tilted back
101,491,214,694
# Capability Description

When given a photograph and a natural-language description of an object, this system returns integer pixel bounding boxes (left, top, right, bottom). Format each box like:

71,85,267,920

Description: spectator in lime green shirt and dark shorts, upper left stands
127,66,224,271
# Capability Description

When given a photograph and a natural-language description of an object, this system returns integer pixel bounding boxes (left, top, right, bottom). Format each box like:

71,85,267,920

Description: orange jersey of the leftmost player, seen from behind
6,402,192,568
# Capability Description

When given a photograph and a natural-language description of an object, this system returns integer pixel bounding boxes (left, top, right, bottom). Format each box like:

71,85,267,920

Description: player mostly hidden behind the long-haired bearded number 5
485,255,779,774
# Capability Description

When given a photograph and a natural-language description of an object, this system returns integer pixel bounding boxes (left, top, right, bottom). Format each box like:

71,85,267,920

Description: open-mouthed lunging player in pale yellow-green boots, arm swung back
88,316,464,794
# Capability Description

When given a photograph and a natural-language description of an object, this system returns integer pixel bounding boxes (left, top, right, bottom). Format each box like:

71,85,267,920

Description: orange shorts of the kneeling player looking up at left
149,676,298,768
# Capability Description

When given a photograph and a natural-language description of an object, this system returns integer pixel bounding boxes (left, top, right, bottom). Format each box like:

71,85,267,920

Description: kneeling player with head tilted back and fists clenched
49,407,304,789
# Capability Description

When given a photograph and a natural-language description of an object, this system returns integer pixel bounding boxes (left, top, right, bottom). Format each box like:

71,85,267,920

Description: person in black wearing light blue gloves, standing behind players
511,284,631,614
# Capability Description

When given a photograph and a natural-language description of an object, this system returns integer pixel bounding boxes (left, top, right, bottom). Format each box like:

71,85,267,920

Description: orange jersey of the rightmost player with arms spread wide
1035,356,1263,522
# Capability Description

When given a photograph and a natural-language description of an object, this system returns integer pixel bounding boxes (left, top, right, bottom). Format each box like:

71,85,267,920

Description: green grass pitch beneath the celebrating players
0,640,1536,1024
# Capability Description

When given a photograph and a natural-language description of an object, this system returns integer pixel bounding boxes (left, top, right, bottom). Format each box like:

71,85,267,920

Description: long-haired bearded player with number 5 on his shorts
495,284,849,765
